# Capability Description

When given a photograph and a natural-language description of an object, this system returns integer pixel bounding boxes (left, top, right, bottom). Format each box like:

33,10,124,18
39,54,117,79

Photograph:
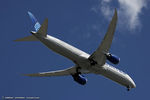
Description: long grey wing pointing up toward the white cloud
89,9,117,65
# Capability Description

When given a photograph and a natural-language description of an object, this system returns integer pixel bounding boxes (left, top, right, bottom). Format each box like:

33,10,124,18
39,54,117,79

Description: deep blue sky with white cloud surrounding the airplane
0,0,150,100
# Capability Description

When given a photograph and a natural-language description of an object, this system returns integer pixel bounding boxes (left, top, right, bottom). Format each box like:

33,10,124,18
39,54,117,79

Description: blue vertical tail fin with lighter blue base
28,11,41,32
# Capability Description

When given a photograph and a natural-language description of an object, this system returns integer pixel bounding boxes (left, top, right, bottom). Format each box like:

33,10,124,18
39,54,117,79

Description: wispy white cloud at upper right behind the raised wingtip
92,0,148,30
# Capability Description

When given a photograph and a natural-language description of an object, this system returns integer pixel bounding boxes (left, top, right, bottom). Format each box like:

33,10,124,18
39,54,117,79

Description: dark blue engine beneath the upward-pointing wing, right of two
106,53,120,64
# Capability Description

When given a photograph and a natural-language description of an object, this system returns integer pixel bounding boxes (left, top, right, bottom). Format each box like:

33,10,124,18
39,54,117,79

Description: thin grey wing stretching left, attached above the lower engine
24,67,89,77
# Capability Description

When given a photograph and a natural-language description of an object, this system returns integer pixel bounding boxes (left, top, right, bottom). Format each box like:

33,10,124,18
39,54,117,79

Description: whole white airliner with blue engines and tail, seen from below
15,9,136,91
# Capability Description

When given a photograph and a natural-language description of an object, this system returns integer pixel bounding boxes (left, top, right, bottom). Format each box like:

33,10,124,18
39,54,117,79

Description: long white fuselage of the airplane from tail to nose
34,34,136,88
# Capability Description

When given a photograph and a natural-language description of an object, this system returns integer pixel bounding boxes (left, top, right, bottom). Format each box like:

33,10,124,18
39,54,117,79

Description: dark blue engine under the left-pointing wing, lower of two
72,74,87,85
